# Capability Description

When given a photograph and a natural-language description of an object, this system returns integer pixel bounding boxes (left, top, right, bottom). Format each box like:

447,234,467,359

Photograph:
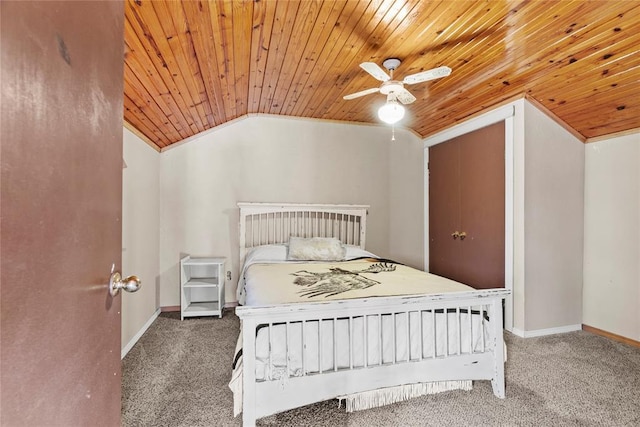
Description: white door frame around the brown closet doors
423,105,515,332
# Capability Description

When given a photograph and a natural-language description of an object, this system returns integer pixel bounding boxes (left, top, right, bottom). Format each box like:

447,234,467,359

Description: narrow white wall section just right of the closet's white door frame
524,102,585,332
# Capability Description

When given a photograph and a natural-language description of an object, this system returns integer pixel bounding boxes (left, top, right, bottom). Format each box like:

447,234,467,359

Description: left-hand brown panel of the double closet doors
429,142,460,280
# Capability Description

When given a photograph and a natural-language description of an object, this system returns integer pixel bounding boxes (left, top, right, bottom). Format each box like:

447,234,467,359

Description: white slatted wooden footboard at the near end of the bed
236,289,510,426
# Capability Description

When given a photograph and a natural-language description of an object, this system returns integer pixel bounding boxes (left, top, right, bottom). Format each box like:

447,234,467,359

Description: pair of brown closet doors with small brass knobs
429,122,505,288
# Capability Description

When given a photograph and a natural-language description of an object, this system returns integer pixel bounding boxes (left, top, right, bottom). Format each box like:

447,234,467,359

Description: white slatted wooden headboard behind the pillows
238,203,369,266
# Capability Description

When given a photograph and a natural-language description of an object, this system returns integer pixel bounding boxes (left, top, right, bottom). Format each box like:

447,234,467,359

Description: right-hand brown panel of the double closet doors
458,122,505,288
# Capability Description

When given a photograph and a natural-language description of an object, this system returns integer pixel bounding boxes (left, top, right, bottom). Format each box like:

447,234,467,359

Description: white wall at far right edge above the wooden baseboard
583,133,640,341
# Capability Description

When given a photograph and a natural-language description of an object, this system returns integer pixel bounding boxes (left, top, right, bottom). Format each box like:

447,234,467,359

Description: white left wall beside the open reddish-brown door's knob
121,129,160,353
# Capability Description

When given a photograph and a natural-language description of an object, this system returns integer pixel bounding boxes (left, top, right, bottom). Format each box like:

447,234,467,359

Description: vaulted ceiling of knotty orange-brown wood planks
124,0,640,149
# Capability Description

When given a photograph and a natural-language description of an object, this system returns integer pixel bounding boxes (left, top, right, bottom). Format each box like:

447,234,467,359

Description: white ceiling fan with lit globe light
343,58,451,124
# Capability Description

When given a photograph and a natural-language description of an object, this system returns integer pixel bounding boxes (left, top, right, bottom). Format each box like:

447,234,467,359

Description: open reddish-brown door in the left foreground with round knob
0,1,124,426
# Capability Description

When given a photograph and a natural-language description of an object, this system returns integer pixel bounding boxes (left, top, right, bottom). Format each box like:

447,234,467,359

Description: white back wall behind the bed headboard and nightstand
160,116,422,307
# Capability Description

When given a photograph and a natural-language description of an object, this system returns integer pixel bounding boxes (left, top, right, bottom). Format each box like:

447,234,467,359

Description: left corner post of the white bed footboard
240,318,256,427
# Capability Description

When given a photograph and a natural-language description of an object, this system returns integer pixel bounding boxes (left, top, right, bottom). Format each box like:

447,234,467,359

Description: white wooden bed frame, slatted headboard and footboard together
236,203,510,426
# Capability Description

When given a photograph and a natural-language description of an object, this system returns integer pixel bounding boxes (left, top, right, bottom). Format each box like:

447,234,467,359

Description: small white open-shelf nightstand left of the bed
180,255,227,320
